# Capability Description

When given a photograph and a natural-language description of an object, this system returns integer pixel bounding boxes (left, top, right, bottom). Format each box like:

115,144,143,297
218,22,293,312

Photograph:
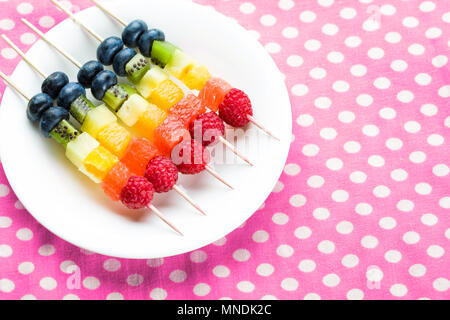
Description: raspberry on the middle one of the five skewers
172,140,210,174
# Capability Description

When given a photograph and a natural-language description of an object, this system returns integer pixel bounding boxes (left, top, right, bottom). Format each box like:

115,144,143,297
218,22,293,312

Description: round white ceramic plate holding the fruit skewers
0,0,292,259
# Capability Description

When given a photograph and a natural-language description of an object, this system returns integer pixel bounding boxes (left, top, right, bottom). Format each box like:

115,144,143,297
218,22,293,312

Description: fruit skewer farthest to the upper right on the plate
89,0,280,141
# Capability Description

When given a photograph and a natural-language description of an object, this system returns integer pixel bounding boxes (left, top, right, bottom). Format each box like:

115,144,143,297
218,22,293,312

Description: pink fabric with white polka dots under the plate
0,0,450,299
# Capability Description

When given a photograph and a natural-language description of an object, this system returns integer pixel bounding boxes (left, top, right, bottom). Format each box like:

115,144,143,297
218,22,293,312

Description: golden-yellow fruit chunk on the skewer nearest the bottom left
80,146,119,182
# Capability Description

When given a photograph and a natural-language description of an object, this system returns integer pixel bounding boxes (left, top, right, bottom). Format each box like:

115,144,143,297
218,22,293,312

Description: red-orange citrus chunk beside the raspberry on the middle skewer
155,115,190,155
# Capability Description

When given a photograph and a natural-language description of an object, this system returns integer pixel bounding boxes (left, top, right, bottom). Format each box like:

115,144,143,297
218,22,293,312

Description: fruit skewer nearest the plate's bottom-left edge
0,71,183,235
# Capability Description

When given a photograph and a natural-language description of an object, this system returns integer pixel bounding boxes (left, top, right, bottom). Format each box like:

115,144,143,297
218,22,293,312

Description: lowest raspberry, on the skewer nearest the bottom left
120,177,154,210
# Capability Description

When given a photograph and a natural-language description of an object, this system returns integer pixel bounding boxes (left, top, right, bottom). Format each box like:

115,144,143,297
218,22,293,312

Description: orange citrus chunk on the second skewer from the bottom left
121,137,159,176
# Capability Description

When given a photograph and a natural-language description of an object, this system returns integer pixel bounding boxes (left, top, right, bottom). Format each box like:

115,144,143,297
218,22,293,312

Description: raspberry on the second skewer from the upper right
189,112,225,147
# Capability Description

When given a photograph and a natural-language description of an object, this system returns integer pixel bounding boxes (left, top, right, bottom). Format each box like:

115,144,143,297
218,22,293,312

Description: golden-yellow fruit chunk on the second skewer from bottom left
97,122,132,159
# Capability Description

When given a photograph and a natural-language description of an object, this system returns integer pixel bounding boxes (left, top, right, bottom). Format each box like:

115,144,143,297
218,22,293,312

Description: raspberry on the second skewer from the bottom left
145,156,178,193
